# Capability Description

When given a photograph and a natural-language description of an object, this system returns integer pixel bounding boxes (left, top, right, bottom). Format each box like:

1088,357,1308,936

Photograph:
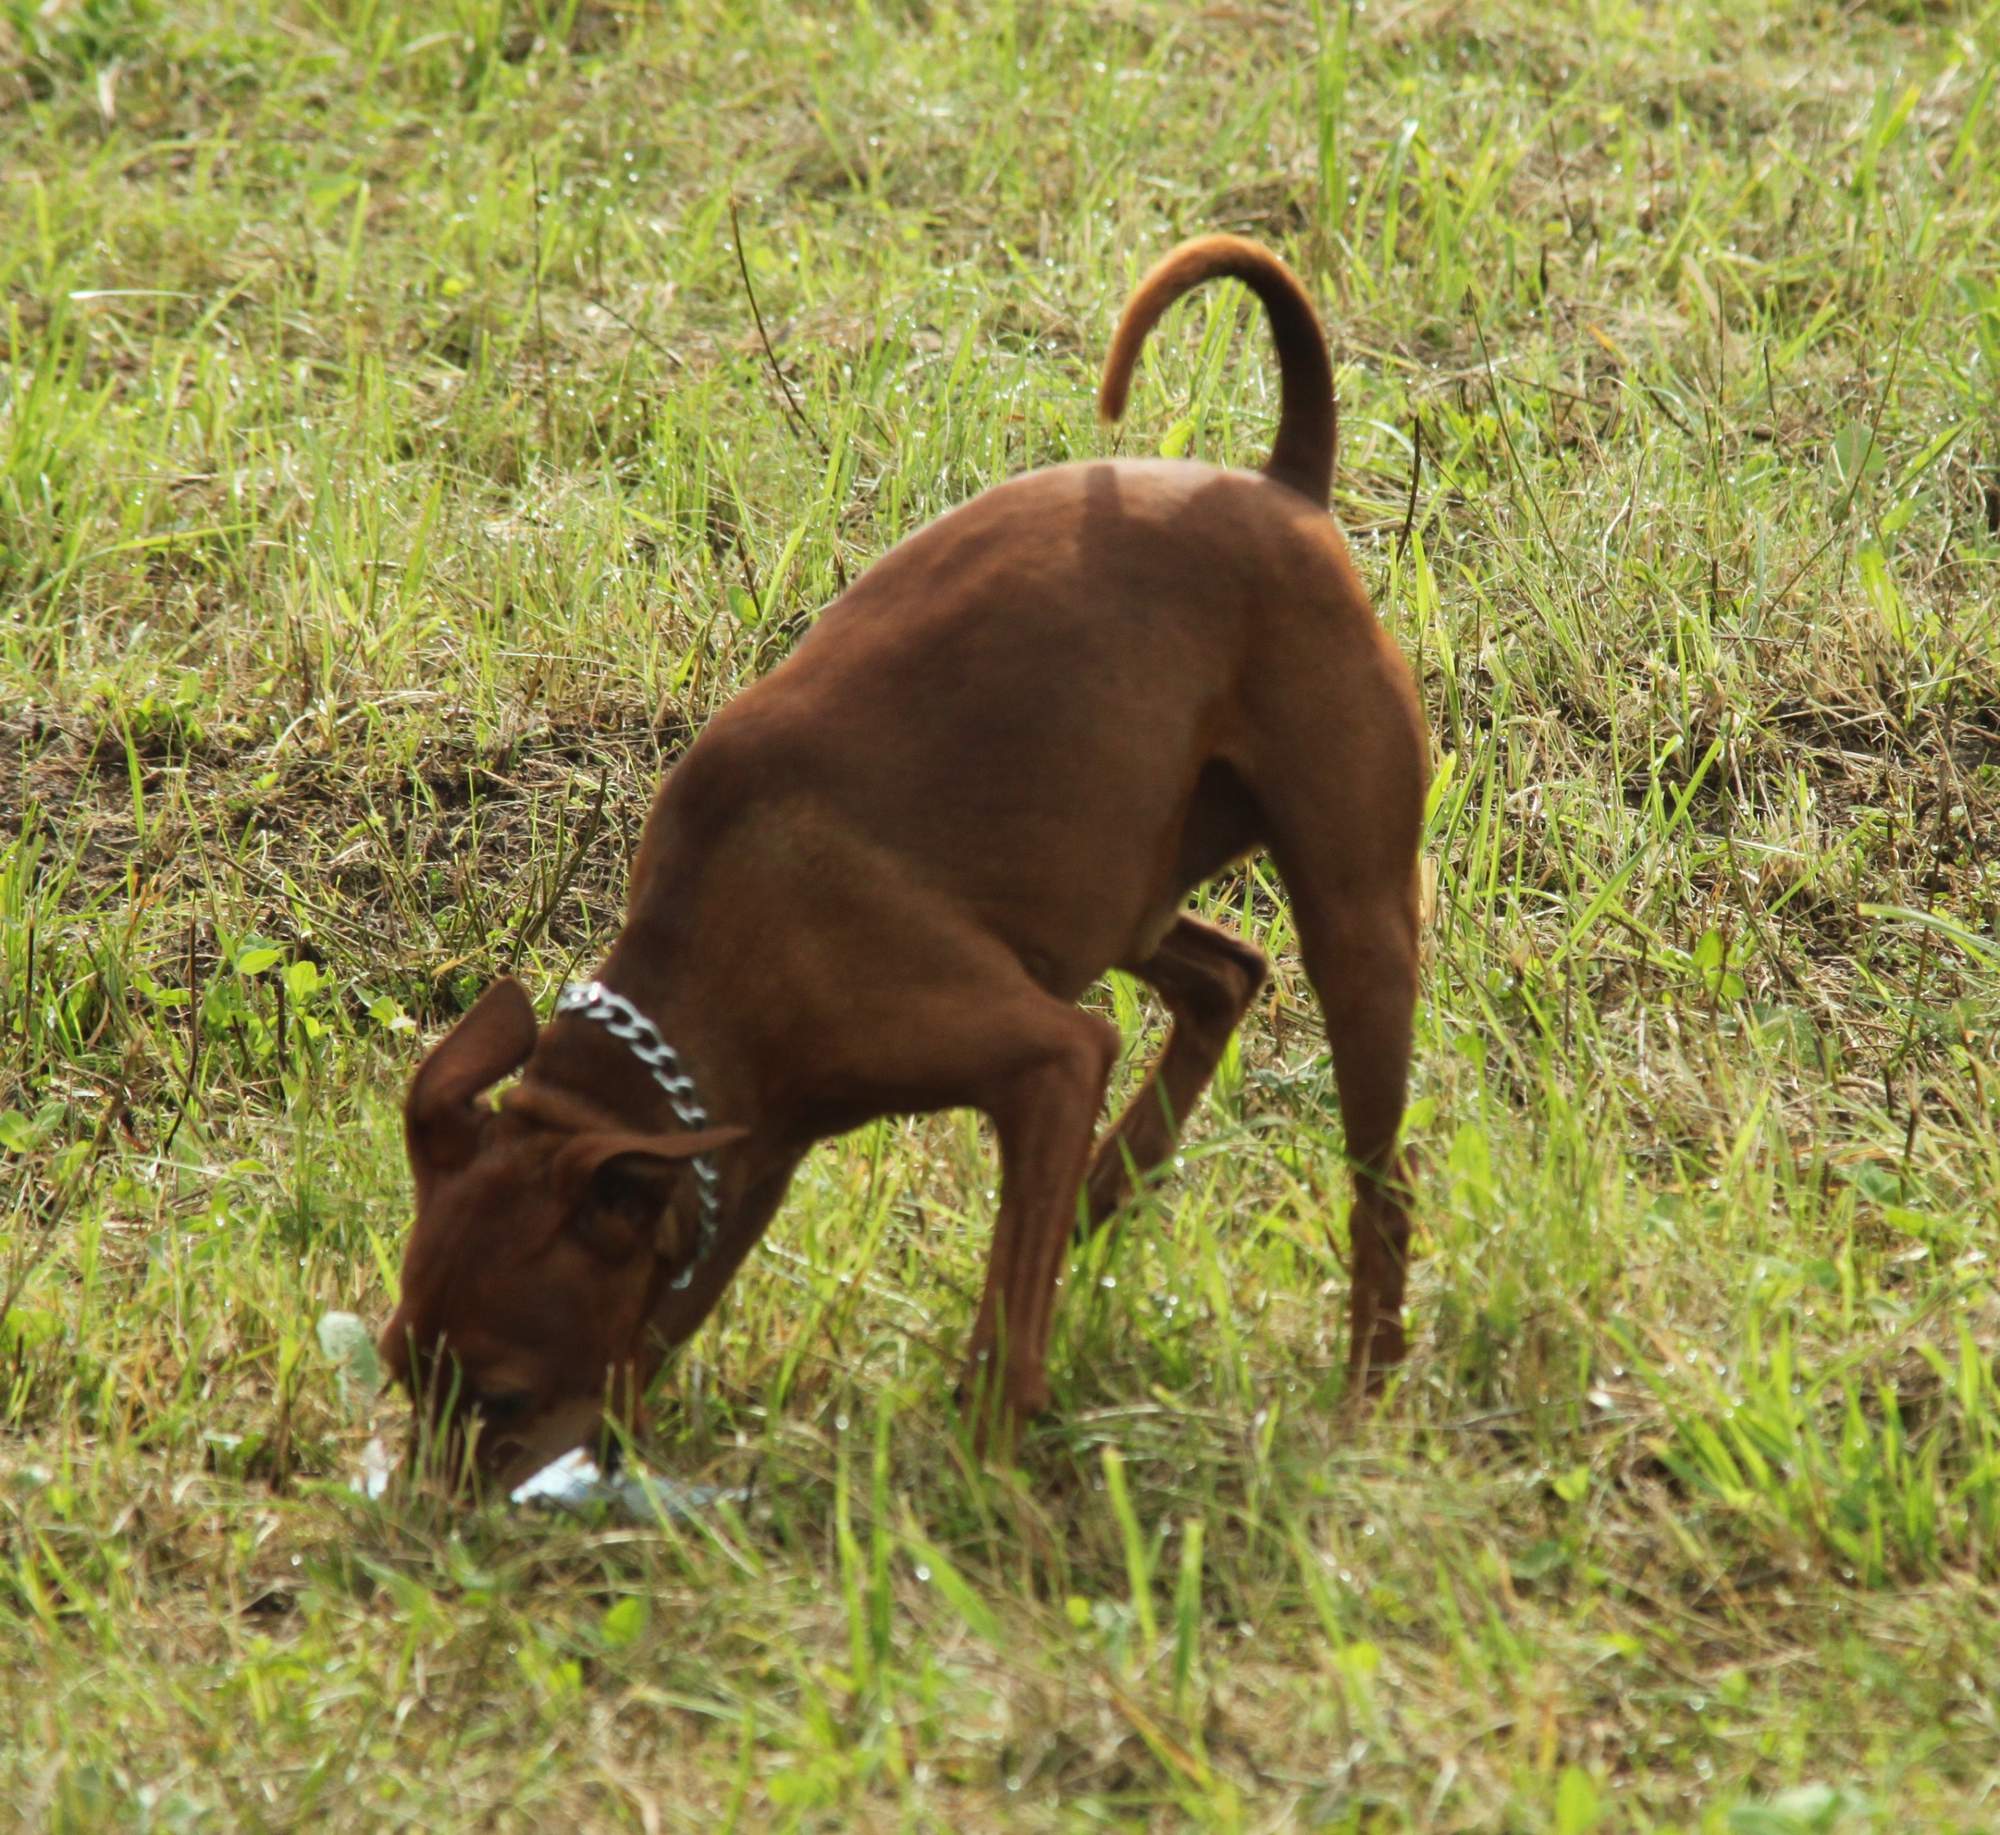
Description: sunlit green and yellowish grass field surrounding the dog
0,0,2000,1835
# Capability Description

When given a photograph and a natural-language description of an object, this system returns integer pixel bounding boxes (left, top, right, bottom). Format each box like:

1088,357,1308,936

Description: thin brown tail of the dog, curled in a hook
1098,236,1340,504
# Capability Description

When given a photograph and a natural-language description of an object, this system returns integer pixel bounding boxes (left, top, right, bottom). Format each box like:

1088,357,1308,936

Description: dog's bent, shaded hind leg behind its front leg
1084,916,1270,1229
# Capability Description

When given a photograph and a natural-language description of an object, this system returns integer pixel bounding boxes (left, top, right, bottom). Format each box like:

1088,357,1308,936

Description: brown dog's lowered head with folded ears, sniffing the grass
380,979,742,1487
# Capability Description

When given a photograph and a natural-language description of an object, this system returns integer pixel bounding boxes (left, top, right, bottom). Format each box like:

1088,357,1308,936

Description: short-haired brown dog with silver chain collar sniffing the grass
382,236,1426,1483
